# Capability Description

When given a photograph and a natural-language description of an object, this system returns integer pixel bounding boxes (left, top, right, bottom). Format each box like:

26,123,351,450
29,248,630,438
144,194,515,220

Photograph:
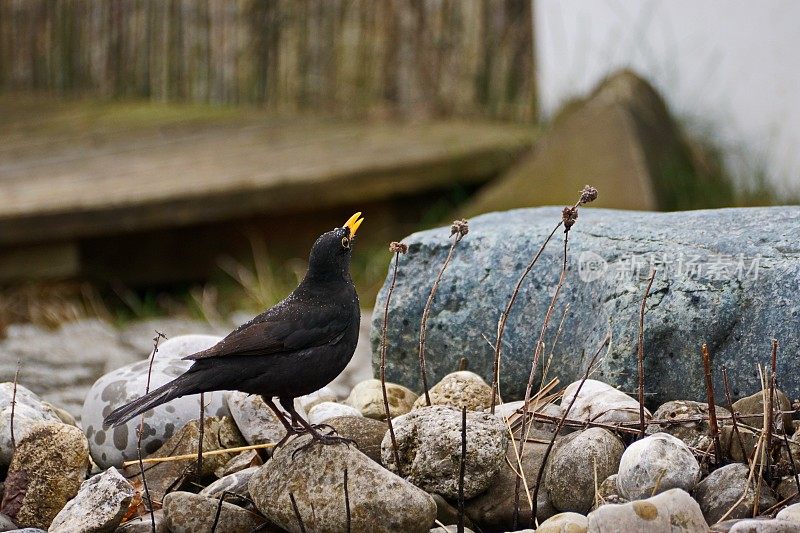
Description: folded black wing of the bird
184,302,353,360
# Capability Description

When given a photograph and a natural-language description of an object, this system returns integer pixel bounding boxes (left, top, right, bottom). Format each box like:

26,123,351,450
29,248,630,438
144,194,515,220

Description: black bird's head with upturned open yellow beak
306,212,364,281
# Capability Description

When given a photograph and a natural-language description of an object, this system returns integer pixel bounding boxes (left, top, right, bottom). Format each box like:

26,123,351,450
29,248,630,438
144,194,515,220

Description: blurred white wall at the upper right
534,0,800,195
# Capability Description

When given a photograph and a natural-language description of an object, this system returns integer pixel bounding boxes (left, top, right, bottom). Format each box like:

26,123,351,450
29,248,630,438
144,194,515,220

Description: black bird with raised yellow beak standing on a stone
103,212,364,443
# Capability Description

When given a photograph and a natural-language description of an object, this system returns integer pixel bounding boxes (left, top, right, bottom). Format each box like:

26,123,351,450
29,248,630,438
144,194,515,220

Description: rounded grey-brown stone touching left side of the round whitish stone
544,428,625,513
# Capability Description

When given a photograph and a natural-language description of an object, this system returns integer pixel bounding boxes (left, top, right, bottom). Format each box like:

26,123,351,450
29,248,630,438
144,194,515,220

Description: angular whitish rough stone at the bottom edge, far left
48,467,134,533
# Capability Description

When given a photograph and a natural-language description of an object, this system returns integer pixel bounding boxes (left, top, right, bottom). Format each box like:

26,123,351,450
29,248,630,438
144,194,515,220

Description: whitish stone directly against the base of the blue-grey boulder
561,379,650,423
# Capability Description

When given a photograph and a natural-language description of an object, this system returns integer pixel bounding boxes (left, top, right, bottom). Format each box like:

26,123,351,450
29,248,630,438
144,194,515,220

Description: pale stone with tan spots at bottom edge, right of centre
588,489,708,533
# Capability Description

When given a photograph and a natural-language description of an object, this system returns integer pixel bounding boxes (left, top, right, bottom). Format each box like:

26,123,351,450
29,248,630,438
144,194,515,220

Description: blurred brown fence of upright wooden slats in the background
0,0,535,121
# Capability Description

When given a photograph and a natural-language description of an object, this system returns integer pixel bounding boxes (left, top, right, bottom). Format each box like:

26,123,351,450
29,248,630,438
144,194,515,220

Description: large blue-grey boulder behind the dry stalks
372,206,800,407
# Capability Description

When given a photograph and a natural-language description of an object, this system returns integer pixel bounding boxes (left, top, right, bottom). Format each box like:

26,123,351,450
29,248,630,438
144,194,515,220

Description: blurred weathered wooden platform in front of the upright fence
0,100,533,244
